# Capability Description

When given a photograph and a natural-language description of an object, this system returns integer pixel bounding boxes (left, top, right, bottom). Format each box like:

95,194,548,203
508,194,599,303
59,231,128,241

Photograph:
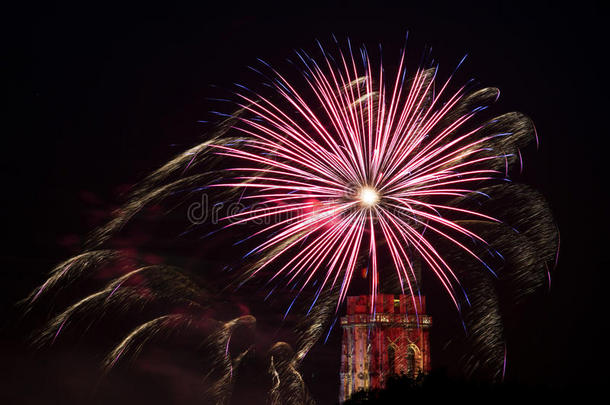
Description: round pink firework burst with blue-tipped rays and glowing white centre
211,40,505,308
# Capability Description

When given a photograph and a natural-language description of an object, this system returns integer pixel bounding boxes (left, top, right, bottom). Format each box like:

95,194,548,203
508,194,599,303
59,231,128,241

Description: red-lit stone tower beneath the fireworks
339,294,432,402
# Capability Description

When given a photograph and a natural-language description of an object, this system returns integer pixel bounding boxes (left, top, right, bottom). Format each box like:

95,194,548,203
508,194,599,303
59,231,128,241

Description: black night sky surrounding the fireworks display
1,1,608,403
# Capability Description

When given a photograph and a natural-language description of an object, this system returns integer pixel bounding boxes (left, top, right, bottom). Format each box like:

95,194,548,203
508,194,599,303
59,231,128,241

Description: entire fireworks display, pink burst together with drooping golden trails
24,37,558,403
